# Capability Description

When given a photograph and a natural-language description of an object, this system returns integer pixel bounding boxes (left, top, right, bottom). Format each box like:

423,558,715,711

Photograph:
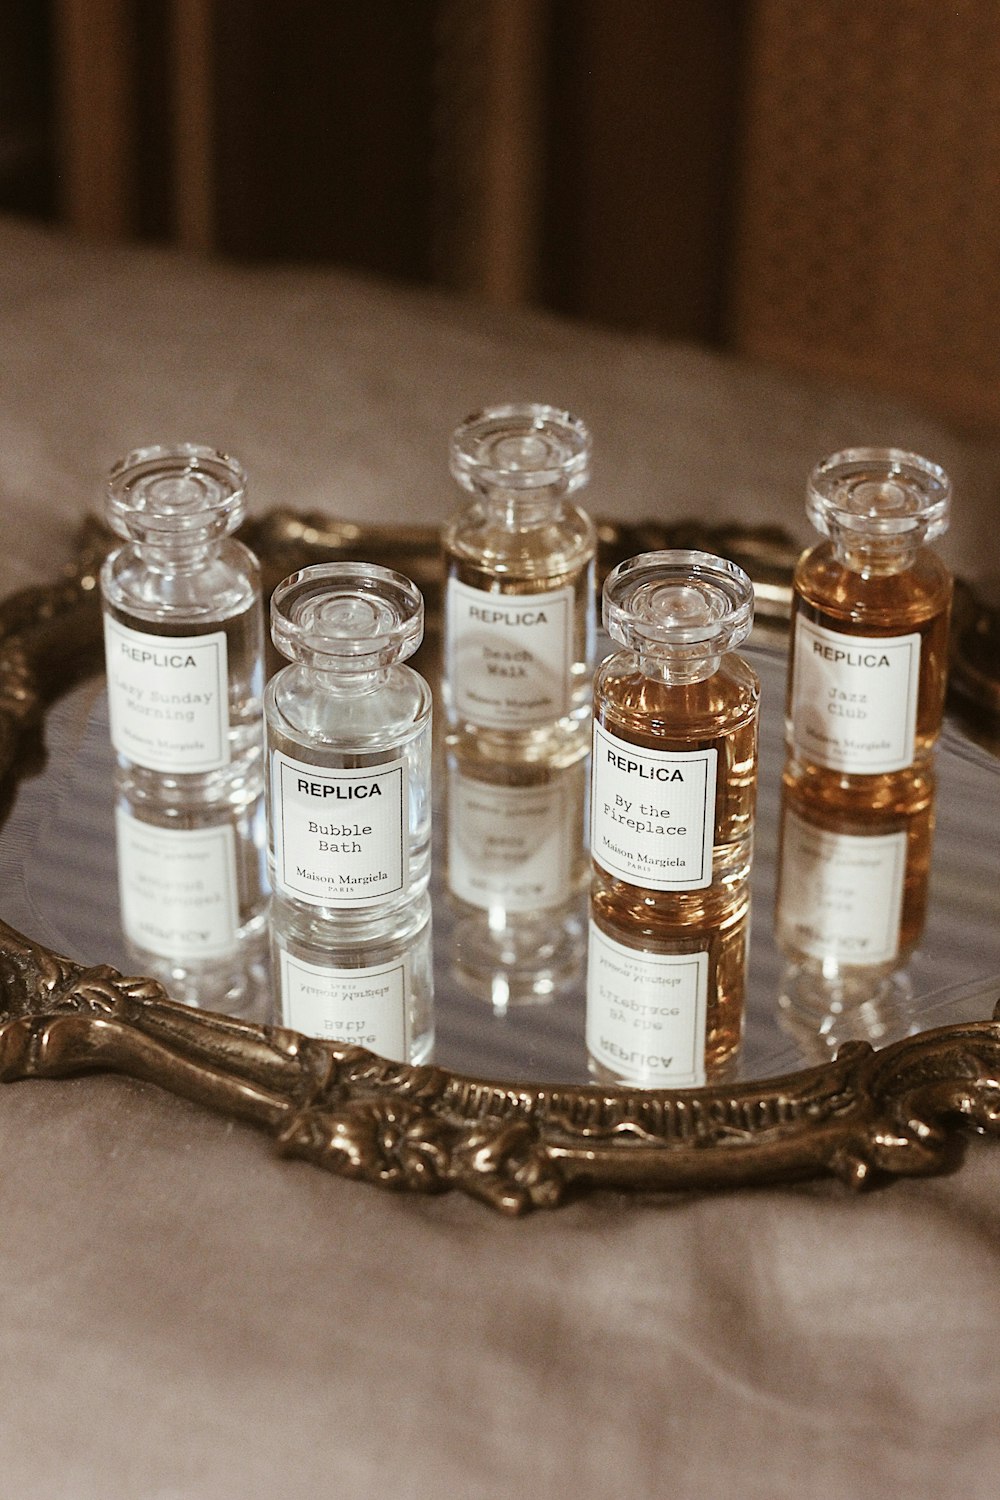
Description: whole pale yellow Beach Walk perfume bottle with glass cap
444,405,597,764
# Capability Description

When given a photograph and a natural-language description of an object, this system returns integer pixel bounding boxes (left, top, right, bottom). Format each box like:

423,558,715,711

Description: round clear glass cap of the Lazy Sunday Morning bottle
106,443,246,543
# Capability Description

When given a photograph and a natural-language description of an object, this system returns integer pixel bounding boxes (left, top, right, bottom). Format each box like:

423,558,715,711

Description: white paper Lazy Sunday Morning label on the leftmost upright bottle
105,615,229,776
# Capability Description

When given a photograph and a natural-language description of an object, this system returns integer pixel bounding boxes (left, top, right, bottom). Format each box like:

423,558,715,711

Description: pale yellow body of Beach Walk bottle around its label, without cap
442,500,597,765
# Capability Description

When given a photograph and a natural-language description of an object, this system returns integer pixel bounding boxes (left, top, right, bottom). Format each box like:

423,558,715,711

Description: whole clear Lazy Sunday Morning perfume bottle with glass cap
100,444,264,806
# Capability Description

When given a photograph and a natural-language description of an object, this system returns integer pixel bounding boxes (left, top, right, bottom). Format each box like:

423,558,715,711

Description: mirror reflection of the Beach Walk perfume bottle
447,756,589,1011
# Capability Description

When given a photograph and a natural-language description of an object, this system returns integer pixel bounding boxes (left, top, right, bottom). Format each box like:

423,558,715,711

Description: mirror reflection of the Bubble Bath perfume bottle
271,893,433,1064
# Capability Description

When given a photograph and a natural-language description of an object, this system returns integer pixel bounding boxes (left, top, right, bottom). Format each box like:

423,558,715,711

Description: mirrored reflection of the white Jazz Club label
777,809,907,965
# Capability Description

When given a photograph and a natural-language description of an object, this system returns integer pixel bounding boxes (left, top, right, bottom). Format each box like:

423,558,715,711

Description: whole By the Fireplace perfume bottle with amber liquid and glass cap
591,551,760,938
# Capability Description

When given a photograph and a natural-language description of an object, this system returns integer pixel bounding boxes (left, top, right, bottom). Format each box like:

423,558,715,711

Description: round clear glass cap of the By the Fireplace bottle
603,548,754,660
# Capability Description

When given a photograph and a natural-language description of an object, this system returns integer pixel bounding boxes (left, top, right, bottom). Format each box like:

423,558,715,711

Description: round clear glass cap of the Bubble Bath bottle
271,563,424,672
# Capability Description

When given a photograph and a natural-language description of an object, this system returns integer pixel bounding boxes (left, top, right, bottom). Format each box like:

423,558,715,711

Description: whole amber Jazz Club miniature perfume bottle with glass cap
787,449,952,809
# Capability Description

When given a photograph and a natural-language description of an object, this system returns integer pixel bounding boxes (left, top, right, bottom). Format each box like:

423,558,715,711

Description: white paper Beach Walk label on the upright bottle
447,578,573,729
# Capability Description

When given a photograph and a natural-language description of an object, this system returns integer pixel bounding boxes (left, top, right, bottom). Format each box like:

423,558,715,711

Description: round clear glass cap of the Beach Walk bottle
451,402,591,495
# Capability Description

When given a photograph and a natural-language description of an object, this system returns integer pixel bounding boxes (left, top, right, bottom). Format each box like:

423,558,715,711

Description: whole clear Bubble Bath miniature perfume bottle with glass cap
264,563,430,924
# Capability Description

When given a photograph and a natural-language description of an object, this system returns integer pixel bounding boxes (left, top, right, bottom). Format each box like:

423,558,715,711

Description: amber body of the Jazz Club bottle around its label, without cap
786,542,952,812
